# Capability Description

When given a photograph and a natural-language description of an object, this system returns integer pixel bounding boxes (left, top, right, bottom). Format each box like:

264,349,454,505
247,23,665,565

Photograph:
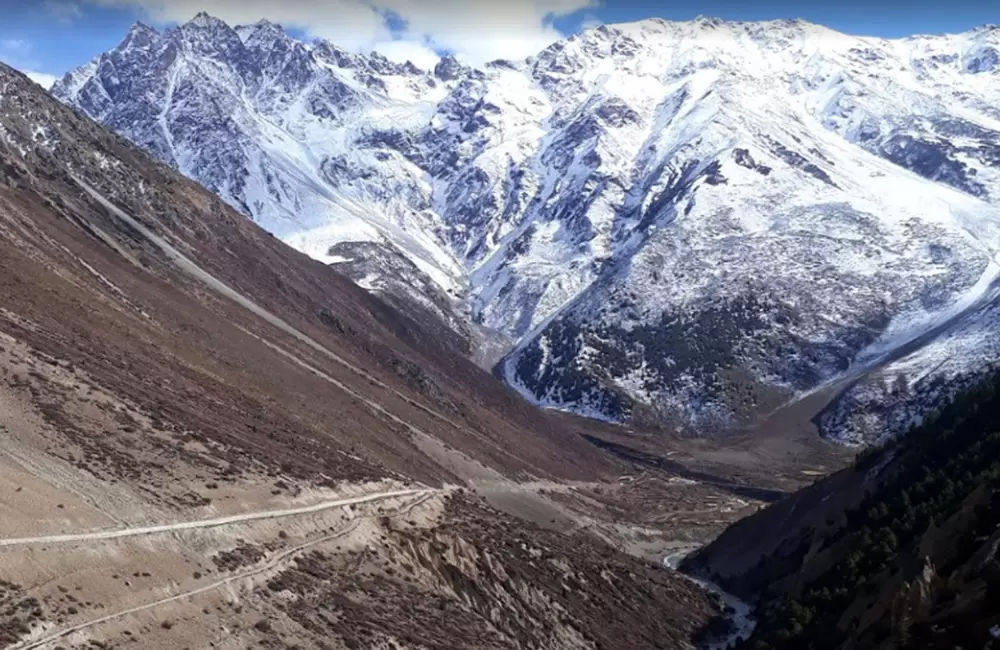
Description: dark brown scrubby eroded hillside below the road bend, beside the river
267,497,710,650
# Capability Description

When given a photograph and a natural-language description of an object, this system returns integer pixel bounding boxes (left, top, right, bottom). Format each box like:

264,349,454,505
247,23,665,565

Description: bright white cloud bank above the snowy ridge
87,0,599,67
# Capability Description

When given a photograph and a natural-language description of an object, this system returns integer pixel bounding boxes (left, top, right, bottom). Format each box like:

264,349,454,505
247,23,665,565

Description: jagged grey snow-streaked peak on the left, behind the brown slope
58,15,470,336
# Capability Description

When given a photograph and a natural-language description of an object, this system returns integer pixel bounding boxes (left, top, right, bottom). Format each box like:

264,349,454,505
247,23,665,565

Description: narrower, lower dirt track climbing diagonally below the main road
10,490,430,650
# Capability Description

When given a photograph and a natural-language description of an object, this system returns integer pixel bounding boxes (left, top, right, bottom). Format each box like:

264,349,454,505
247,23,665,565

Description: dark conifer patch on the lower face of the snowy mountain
516,291,811,425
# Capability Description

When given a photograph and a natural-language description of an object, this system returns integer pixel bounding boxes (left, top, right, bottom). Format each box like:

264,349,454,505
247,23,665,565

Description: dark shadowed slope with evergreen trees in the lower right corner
686,375,1000,649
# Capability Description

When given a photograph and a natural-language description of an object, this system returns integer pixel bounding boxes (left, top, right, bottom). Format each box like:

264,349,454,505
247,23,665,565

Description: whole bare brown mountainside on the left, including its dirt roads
0,65,747,650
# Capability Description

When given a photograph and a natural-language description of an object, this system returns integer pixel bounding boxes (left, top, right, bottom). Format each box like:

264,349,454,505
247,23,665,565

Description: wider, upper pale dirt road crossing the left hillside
0,489,433,547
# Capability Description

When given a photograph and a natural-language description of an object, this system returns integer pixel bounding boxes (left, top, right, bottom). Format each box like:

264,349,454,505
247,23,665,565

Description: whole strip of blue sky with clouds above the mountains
0,0,1000,85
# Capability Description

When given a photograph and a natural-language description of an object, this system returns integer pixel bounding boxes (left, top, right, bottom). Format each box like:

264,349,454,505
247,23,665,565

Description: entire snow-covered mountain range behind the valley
54,15,1000,439
